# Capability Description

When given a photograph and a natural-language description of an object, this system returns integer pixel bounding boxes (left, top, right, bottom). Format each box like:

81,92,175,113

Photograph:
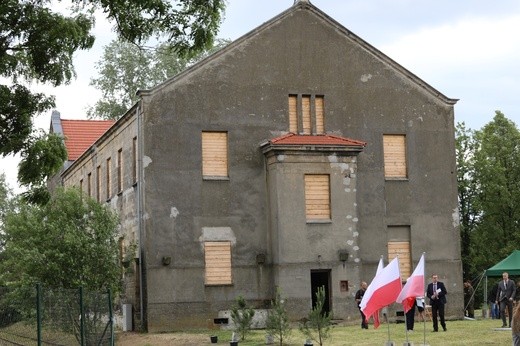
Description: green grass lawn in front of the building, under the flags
121,319,512,346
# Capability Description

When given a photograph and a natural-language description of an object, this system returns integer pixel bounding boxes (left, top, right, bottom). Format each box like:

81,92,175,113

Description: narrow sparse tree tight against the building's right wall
455,123,478,278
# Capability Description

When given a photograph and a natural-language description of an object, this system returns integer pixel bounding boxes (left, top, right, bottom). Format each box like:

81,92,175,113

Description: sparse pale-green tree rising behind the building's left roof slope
88,40,229,119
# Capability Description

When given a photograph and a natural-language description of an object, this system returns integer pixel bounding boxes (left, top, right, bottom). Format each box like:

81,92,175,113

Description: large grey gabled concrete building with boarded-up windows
50,1,463,331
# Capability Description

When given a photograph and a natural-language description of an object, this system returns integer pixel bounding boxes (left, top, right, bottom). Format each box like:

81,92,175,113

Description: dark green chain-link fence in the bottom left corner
0,285,114,346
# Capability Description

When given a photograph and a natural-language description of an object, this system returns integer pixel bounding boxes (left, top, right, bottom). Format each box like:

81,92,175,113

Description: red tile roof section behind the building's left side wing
61,119,115,161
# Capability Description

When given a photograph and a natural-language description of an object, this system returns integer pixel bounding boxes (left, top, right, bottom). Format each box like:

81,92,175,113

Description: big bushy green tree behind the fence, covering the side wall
0,189,120,293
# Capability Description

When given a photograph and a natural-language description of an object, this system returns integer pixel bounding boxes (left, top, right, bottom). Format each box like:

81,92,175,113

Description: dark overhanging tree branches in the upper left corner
0,0,225,196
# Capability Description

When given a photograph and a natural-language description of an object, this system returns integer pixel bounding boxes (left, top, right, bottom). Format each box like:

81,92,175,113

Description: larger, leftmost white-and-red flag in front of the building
360,257,401,321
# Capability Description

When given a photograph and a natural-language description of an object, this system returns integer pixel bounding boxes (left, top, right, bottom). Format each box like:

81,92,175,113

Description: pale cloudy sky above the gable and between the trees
0,0,520,186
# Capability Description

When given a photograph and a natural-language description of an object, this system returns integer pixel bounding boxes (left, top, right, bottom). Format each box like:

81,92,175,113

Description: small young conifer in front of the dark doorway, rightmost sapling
300,286,332,346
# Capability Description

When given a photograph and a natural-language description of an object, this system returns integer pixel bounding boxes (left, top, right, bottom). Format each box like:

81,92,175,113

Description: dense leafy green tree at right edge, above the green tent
471,111,520,270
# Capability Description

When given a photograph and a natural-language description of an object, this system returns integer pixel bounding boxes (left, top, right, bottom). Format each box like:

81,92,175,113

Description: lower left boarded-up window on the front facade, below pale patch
204,241,232,285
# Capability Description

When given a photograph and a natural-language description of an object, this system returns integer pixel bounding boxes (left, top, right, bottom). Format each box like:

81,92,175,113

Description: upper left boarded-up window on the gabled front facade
202,132,228,177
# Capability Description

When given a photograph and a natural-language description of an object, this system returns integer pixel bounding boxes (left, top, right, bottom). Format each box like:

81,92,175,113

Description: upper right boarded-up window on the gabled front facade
383,135,407,178
